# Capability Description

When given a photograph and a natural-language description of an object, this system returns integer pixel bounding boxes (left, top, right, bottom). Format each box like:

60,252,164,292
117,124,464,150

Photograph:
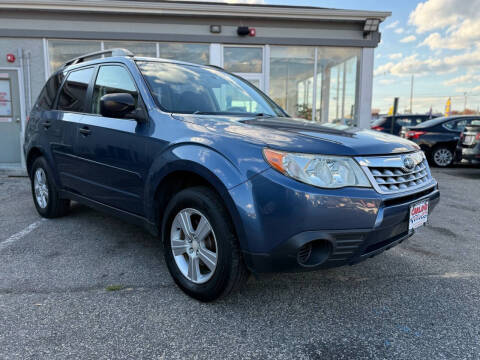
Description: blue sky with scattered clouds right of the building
189,0,480,113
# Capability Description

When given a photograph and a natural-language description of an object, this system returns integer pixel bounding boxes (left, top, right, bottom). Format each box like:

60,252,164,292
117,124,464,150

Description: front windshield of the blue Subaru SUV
137,61,287,117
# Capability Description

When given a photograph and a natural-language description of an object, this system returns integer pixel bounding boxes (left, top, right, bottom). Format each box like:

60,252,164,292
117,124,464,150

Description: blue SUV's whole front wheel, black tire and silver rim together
162,187,248,302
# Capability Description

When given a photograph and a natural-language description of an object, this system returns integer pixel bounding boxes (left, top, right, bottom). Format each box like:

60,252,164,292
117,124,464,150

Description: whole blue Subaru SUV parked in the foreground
24,49,440,301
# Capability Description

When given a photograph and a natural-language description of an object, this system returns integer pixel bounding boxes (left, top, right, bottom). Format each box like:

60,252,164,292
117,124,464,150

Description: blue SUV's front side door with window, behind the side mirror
71,64,153,215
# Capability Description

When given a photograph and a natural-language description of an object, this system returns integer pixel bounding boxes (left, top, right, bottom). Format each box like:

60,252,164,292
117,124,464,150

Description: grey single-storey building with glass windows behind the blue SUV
0,0,390,167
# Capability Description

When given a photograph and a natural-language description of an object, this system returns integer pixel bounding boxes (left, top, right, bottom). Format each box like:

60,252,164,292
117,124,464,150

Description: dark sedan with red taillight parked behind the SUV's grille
401,116,479,167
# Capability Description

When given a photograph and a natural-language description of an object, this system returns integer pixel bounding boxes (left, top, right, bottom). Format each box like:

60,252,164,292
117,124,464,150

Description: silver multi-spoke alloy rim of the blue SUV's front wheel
170,208,218,284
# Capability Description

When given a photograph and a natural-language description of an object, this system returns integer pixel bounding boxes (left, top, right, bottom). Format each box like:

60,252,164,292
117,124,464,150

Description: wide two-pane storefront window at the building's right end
270,46,361,126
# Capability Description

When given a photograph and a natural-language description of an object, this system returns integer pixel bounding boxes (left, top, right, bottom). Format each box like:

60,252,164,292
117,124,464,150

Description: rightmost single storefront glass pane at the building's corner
315,47,361,126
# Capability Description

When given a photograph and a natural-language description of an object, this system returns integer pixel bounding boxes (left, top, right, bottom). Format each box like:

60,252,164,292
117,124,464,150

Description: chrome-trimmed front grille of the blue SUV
359,152,432,194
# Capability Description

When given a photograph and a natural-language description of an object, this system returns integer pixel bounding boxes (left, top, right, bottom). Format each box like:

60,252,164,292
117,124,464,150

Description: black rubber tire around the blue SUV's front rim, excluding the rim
162,189,233,301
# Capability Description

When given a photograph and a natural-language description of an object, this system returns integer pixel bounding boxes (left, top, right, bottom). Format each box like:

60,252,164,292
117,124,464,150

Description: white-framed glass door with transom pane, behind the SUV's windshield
222,45,265,91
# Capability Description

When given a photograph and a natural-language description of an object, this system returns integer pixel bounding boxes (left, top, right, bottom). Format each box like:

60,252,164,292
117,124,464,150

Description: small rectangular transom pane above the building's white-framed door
223,46,263,73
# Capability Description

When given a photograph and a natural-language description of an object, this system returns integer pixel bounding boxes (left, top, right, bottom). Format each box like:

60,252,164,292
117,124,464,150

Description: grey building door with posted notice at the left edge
0,70,22,164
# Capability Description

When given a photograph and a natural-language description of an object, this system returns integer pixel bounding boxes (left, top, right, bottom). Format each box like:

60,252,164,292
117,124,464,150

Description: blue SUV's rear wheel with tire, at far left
30,157,70,218
